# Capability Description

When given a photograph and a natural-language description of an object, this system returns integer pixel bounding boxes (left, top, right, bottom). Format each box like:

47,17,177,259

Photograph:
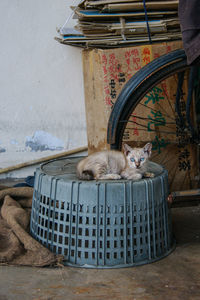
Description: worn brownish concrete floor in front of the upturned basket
0,181,200,300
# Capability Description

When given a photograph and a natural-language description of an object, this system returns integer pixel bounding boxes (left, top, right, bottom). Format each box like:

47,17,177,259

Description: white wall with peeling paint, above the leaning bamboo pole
0,0,87,176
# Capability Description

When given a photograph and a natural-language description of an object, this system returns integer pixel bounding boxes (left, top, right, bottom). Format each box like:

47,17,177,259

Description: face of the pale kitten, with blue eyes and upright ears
123,143,152,169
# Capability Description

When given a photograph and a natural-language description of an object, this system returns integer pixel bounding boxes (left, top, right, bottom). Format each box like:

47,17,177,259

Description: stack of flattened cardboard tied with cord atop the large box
56,0,181,48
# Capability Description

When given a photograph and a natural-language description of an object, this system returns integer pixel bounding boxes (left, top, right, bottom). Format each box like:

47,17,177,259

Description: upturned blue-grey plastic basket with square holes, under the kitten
31,158,174,268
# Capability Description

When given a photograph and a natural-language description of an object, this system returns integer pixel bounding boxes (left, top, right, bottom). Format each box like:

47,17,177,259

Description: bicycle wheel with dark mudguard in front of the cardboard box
107,50,199,190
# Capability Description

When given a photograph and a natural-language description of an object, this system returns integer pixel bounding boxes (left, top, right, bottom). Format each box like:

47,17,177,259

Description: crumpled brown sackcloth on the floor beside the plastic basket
0,187,57,267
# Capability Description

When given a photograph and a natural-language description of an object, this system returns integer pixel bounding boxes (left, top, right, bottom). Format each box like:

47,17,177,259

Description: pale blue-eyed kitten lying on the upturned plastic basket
77,143,154,180
